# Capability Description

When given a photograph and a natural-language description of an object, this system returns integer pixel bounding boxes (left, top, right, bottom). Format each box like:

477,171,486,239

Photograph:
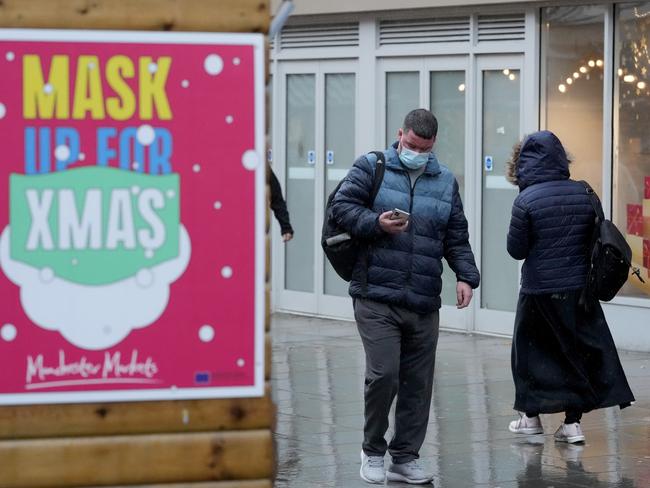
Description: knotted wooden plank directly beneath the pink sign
0,385,274,440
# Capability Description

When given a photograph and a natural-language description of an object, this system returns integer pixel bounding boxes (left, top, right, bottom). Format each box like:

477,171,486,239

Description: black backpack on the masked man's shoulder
320,151,386,281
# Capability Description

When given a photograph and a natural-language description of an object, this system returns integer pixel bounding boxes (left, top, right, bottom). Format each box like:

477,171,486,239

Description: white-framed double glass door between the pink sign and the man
273,61,359,318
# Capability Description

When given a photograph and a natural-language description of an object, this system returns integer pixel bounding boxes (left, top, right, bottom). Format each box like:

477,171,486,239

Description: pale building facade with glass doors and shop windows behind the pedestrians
269,0,650,351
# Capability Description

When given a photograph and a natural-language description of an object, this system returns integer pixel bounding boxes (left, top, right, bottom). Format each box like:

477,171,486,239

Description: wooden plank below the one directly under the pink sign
0,430,273,488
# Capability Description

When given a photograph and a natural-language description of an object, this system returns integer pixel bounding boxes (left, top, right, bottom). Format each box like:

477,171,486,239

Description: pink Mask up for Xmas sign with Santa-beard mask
0,30,265,404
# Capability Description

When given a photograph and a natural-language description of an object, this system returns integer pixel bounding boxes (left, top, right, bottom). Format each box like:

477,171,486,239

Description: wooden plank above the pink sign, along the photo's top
0,0,270,33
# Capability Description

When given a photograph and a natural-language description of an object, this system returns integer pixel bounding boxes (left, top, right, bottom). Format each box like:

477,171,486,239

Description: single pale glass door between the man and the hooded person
474,56,532,334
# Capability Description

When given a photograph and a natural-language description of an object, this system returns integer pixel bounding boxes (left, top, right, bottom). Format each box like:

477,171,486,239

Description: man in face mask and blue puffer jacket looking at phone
332,109,479,484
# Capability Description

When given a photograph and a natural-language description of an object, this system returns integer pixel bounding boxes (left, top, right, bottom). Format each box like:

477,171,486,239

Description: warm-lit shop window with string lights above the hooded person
541,6,606,194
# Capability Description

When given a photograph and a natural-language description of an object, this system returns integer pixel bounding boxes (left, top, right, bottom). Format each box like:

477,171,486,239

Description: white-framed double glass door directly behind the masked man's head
377,56,474,330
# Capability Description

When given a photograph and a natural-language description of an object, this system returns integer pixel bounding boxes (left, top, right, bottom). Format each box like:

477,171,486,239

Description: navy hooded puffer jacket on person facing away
508,131,596,294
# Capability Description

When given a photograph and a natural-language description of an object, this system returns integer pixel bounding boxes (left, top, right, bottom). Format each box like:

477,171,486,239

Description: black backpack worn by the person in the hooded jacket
581,181,645,302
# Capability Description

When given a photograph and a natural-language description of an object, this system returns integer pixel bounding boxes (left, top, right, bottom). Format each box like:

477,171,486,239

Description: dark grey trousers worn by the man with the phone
354,298,439,464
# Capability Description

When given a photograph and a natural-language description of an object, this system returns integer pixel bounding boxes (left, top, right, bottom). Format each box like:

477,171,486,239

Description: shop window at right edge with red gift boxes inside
613,2,650,298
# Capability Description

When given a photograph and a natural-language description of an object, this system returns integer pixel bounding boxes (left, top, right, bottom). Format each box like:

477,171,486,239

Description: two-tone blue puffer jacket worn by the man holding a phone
332,143,480,313
